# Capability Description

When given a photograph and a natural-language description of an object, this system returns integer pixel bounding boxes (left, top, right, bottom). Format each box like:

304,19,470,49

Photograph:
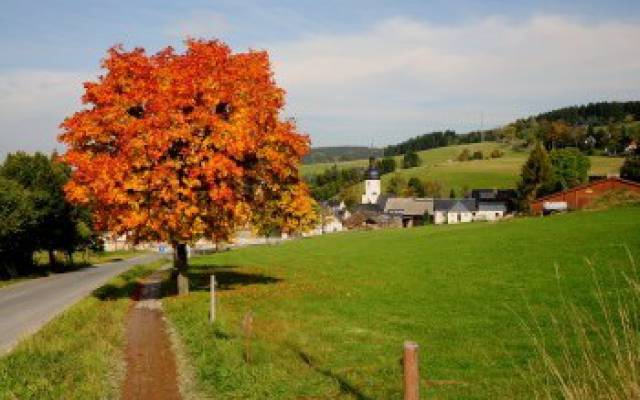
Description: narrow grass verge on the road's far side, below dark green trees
0,250,146,288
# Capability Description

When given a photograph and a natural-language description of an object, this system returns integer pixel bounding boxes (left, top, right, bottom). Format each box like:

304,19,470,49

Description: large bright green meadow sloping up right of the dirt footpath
165,208,640,399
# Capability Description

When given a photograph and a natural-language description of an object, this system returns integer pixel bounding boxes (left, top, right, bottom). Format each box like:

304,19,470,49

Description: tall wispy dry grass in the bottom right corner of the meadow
522,247,640,400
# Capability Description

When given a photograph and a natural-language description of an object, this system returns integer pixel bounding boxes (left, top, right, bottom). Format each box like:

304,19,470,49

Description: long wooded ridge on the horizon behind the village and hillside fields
304,101,640,164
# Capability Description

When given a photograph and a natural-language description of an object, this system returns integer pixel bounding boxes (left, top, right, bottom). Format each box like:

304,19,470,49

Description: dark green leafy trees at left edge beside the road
0,152,99,278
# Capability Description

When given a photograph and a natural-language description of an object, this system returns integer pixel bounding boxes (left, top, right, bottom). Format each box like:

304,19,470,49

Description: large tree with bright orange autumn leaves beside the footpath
60,40,315,293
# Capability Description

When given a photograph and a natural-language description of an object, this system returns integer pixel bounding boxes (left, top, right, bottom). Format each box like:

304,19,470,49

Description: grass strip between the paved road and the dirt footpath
0,261,166,400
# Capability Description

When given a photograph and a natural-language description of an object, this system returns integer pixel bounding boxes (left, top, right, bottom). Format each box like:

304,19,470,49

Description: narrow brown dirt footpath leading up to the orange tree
122,272,180,400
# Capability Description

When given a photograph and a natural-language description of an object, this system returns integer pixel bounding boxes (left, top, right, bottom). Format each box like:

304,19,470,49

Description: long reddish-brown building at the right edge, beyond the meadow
531,176,640,215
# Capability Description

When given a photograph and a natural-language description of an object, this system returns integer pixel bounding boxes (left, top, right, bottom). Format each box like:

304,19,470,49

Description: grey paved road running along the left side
0,254,162,355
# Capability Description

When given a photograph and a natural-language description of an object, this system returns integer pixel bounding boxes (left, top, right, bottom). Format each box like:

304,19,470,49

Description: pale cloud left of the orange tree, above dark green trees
0,70,90,159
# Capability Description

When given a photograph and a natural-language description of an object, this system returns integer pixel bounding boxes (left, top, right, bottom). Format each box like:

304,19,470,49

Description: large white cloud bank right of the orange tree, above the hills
267,15,640,144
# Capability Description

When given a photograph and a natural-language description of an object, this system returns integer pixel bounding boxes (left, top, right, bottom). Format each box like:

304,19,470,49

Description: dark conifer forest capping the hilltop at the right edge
535,101,640,125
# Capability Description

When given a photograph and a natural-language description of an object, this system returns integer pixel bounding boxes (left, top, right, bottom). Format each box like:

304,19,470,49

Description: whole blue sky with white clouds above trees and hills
0,0,640,158
